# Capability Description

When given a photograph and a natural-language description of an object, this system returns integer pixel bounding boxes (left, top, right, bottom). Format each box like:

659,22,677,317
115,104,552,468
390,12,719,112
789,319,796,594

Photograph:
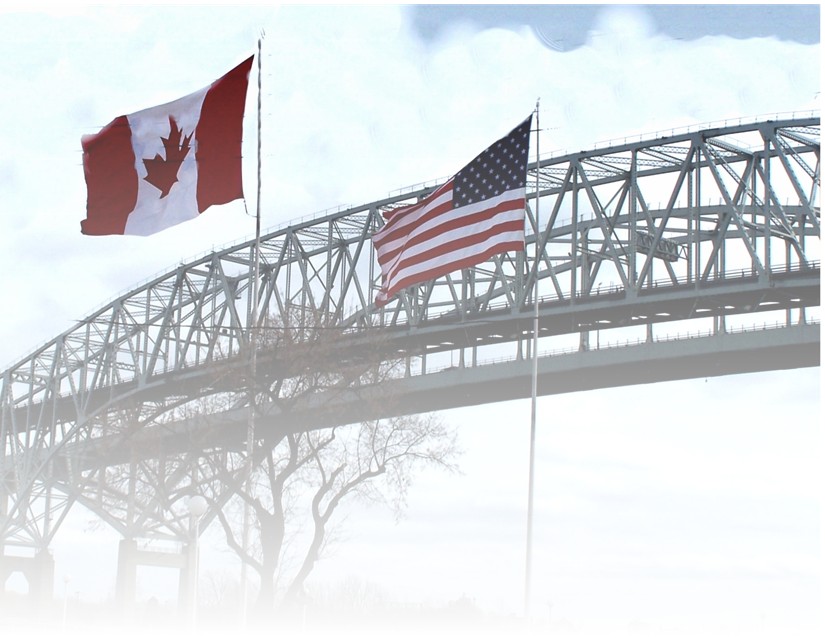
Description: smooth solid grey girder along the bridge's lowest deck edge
58,324,821,469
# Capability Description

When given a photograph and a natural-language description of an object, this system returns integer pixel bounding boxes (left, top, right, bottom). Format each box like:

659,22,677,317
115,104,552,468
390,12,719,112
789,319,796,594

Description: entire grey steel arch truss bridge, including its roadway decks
0,116,821,592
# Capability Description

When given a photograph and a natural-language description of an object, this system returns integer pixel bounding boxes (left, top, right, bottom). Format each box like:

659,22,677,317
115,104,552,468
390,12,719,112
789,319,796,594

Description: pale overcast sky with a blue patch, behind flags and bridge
0,5,822,636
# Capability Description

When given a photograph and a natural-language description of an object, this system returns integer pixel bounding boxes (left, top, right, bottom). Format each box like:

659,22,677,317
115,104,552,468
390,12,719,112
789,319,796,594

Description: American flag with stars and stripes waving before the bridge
372,115,533,306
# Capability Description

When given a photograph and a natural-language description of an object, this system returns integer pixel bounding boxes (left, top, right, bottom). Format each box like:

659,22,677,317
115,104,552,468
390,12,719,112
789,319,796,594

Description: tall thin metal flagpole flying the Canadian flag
241,36,263,624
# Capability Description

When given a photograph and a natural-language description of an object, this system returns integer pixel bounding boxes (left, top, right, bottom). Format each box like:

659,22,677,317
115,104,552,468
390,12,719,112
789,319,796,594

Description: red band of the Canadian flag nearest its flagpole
195,57,253,213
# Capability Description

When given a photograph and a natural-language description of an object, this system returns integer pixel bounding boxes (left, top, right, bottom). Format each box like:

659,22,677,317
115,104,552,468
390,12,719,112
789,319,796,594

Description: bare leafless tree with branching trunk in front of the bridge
200,311,458,613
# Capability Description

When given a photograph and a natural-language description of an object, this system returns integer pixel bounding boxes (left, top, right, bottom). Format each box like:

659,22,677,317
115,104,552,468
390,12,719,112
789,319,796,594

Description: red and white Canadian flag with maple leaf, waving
80,57,253,235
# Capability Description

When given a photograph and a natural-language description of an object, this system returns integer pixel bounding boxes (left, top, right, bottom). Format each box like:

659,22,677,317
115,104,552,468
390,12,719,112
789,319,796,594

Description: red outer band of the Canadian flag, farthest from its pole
80,115,138,235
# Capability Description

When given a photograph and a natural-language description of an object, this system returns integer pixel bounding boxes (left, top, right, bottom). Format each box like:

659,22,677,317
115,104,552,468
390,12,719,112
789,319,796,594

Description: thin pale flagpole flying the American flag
524,100,541,619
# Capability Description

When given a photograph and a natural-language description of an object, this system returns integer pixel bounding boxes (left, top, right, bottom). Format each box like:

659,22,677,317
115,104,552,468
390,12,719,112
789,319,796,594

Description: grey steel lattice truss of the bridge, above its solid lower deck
0,118,821,546
